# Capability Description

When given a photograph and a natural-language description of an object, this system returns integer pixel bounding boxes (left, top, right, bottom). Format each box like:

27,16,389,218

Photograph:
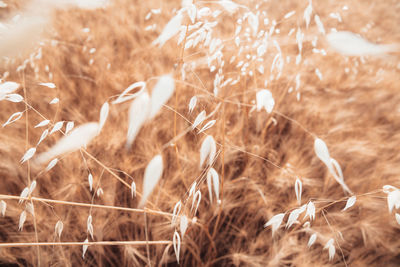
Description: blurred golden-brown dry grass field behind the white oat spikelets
0,0,400,266
